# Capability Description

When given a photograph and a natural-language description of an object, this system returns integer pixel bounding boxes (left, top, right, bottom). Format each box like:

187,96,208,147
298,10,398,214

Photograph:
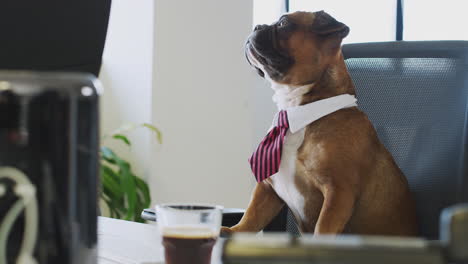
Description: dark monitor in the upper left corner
0,0,111,76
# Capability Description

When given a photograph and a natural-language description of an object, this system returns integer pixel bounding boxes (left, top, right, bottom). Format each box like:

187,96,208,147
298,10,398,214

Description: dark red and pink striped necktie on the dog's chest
249,110,289,182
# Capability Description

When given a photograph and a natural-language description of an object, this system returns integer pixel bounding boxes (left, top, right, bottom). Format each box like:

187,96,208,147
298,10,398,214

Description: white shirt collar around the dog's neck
274,94,357,133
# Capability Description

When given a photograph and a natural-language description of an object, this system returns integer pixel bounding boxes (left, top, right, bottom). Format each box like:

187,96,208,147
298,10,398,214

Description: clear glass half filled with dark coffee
156,204,223,264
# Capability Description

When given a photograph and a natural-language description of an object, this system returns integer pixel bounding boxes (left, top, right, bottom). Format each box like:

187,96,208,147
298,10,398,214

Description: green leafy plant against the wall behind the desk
100,123,162,222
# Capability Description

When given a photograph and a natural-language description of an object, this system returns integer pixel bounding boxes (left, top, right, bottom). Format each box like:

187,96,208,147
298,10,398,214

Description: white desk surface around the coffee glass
98,217,222,264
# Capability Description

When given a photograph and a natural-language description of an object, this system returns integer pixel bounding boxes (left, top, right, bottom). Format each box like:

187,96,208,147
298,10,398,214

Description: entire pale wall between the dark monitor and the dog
100,0,286,210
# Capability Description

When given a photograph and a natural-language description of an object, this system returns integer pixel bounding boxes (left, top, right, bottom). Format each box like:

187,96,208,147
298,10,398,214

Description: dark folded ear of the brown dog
312,11,349,39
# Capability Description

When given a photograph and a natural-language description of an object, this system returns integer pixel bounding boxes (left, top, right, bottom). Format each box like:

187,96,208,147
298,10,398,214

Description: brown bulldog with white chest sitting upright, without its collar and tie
222,11,417,236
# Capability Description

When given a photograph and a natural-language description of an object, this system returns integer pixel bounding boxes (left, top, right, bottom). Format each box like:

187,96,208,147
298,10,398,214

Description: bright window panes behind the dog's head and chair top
254,0,468,43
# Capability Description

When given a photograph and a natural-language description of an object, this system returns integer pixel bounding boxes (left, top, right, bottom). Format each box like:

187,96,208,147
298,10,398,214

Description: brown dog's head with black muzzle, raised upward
245,11,349,86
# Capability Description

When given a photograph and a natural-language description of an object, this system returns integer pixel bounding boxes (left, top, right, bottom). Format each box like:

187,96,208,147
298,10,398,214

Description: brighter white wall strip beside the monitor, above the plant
100,0,154,177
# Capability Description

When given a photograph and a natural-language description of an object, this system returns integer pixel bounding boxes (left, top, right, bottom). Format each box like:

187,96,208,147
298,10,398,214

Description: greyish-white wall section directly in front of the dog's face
151,0,257,207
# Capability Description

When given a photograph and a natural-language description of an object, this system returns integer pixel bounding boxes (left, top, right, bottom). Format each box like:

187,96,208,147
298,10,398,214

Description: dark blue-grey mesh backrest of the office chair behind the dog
343,41,468,239
